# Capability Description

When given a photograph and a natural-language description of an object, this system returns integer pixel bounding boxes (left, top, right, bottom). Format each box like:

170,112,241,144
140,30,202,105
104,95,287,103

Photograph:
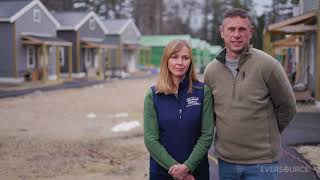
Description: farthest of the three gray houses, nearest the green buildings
104,19,141,74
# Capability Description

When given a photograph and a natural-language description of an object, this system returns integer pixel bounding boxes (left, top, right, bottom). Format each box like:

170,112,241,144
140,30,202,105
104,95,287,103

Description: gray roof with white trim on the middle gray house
52,11,108,34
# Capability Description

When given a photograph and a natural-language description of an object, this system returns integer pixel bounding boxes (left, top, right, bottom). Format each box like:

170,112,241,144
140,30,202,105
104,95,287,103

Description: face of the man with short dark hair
220,16,253,54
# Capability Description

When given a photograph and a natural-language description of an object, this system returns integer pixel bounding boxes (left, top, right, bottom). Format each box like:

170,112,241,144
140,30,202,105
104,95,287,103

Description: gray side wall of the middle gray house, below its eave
57,31,77,73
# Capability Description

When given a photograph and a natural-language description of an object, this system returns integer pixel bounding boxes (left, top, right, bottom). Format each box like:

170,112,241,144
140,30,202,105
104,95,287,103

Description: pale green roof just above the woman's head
140,34,191,47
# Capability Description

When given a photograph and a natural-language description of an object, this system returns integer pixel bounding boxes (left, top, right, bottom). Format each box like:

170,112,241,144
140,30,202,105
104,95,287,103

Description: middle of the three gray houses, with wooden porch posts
52,12,108,78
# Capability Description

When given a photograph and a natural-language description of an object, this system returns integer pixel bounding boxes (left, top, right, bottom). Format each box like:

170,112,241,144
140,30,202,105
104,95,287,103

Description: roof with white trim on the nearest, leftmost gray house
0,0,60,27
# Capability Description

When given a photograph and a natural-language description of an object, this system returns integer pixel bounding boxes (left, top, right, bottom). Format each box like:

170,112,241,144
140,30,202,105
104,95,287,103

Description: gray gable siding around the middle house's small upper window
79,18,104,39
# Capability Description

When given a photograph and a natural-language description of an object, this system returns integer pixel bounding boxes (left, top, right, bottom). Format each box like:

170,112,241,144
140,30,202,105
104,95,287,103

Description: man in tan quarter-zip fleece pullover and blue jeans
204,9,296,180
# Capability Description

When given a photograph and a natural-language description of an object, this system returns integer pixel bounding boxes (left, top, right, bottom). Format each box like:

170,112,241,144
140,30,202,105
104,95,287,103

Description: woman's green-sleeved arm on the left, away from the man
143,89,178,170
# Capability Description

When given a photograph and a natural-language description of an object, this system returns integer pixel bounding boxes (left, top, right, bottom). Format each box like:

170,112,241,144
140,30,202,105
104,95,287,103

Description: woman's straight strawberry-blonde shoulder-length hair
156,39,198,95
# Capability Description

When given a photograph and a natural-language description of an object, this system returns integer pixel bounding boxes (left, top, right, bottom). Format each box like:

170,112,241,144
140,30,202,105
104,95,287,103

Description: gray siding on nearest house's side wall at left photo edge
0,22,14,77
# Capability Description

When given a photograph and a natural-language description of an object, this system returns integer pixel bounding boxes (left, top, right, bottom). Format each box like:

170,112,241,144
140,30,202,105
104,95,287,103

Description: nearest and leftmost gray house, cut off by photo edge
0,0,72,83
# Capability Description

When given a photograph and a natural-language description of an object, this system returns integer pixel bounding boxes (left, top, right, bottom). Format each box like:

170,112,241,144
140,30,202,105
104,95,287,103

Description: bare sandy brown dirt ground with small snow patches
0,77,319,180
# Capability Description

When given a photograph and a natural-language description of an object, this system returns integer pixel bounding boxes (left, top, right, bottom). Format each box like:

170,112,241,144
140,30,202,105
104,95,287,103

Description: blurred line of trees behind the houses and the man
41,0,299,48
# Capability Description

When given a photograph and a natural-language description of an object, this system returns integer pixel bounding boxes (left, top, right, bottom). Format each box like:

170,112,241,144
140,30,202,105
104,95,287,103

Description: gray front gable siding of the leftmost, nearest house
16,5,56,75
